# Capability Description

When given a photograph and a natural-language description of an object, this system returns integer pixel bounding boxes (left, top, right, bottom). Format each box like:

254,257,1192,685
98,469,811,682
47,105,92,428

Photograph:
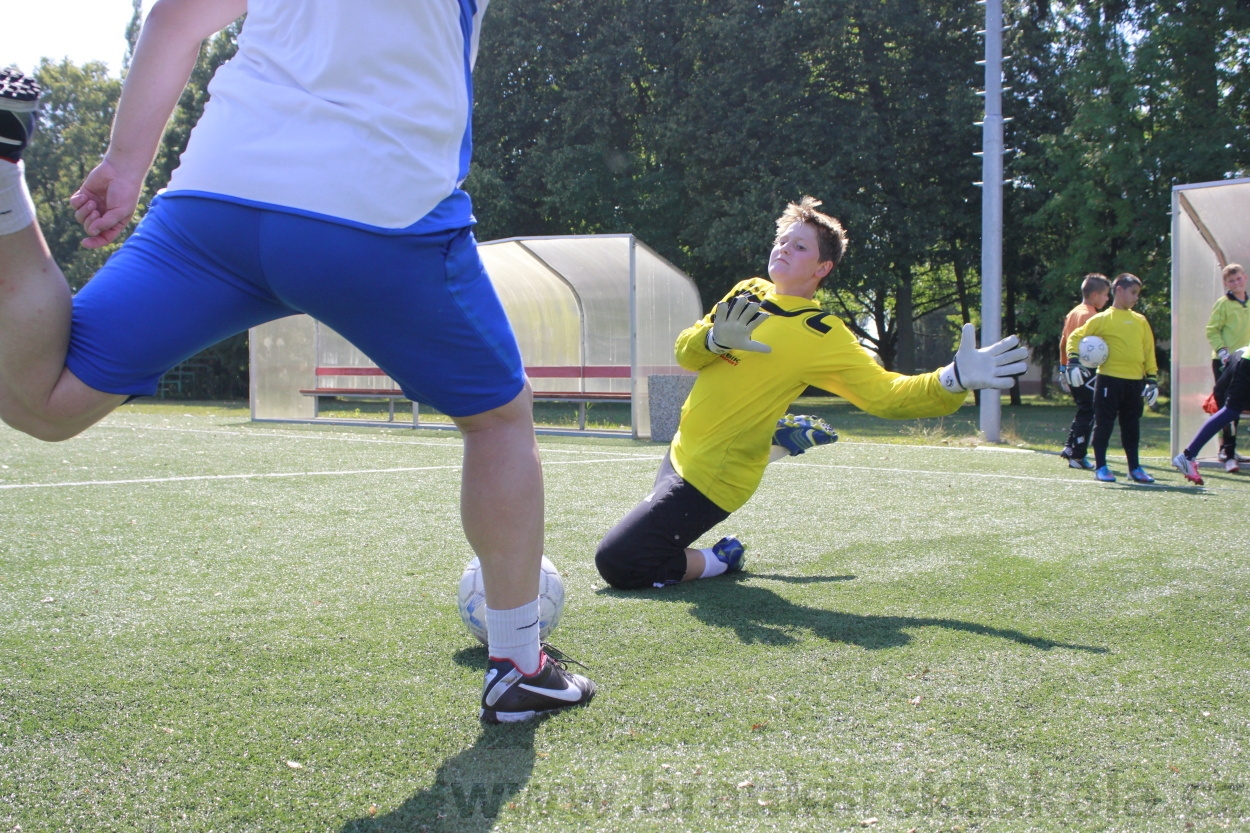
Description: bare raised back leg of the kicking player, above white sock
0,224,126,440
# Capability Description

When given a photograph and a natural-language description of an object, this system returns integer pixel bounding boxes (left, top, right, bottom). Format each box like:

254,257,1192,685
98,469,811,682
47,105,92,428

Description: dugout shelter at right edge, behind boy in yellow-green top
1171,179,1250,460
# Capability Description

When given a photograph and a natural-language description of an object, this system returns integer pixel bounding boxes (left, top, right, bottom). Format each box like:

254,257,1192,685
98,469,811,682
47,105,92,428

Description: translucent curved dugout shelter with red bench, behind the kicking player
250,234,703,439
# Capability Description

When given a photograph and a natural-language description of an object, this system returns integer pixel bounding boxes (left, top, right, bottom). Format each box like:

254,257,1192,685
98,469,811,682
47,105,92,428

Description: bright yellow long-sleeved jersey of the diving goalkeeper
670,278,965,512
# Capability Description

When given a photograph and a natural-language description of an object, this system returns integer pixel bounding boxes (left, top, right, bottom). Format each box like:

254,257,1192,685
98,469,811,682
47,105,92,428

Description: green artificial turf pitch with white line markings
0,400,1250,833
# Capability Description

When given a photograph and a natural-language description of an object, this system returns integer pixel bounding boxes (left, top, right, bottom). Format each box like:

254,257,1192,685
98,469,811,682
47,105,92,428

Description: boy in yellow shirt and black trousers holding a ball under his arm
1068,273,1159,483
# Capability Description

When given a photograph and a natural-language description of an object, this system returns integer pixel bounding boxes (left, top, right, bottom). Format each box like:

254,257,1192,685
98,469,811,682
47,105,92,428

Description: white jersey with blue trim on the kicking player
168,0,489,231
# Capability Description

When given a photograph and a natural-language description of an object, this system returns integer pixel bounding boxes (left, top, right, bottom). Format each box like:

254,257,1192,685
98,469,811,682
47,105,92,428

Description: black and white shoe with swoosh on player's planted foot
481,645,595,723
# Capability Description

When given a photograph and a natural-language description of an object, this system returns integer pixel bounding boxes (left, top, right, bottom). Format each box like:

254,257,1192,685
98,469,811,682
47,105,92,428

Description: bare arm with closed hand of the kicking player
70,0,248,249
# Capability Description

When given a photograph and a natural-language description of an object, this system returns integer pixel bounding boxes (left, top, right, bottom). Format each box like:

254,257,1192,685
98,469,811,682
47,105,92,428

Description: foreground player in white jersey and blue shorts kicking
0,0,595,722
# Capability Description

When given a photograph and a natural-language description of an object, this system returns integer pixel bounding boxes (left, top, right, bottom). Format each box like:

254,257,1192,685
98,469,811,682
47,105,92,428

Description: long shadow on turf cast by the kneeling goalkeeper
599,573,1108,654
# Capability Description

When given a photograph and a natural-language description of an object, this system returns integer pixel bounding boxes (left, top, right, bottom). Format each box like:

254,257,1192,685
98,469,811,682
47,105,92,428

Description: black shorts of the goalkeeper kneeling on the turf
595,454,729,590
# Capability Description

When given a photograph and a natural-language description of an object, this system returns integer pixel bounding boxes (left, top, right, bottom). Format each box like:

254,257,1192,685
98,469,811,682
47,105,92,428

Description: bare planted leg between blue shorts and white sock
455,385,544,602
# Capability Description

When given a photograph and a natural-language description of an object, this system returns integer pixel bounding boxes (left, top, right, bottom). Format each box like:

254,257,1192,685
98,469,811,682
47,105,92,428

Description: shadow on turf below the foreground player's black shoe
340,719,541,833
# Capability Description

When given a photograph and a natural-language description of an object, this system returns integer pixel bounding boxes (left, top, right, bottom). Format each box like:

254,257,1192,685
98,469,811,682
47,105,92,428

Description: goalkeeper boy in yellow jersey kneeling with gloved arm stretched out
595,196,1028,589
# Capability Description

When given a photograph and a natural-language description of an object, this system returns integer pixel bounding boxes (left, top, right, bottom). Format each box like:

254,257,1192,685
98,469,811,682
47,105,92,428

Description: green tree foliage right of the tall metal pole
1005,1,1250,370
